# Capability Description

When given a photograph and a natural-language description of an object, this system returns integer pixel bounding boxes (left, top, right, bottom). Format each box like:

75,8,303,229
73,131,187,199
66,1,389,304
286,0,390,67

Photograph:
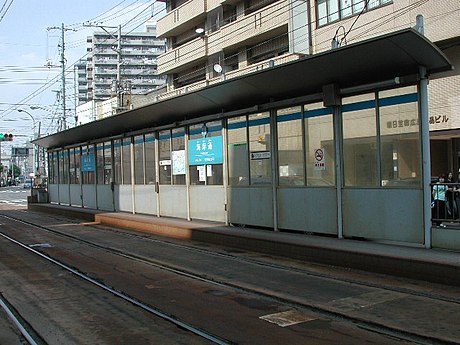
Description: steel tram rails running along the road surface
0,215,460,344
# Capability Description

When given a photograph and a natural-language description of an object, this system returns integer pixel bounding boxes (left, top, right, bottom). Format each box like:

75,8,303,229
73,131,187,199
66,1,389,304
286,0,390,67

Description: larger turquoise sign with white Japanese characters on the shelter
188,136,224,165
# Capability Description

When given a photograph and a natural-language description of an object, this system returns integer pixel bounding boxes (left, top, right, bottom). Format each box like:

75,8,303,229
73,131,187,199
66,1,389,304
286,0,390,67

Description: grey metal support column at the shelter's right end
419,66,431,248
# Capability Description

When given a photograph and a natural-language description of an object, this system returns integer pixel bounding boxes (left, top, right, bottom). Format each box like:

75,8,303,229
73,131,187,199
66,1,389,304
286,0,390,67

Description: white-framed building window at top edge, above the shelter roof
316,0,392,26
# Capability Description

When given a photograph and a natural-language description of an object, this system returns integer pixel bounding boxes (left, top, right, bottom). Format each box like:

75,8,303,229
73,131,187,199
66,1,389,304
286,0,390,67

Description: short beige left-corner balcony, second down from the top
158,37,206,74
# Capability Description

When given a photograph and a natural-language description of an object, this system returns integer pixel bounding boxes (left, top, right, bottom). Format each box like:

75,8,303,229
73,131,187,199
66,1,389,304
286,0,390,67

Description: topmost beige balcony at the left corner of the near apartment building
157,0,206,37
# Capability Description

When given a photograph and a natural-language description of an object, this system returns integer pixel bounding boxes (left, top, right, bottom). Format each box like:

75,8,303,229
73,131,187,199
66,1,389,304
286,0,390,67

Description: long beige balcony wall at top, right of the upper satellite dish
208,0,289,55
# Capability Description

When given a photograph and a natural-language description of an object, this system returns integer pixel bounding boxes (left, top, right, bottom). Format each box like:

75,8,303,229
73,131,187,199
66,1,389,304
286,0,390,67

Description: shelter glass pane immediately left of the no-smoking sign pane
277,107,305,186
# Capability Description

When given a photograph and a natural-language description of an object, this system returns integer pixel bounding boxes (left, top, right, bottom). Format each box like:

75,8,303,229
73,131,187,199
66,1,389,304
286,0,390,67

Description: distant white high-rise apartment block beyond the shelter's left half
83,25,165,104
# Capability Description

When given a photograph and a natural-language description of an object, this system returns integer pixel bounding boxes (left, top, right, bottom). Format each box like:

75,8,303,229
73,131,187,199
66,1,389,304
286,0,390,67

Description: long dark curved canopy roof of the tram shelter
34,29,452,149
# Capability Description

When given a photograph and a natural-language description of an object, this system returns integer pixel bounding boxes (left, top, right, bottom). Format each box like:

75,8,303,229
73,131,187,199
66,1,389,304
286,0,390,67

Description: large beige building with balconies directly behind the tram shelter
158,0,460,176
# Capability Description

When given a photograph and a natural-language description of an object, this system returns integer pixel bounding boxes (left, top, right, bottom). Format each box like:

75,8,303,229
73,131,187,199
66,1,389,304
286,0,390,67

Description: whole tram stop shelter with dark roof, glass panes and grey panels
34,29,454,249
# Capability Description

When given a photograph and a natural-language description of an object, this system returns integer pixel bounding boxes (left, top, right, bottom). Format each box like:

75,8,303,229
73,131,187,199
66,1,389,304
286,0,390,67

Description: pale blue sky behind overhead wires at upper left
0,0,164,153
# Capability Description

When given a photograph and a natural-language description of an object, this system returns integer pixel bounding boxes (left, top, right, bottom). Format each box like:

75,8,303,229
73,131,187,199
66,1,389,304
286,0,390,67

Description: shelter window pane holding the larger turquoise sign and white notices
189,121,223,185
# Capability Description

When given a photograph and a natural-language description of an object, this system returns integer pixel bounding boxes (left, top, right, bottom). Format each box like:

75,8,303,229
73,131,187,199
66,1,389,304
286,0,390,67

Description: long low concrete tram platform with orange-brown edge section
28,203,460,286
